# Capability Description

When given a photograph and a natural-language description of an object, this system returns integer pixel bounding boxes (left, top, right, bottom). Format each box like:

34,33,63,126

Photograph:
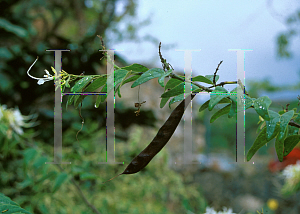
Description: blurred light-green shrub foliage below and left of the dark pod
0,120,206,214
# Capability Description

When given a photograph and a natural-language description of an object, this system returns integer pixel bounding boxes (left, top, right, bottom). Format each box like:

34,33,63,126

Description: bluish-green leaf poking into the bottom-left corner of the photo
0,193,31,214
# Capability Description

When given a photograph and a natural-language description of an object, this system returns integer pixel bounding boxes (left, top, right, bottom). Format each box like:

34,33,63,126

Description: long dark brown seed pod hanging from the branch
103,95,195,181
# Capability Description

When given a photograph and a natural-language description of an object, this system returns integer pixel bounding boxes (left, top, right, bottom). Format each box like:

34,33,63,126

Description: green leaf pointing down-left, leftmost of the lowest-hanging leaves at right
247,124,280,161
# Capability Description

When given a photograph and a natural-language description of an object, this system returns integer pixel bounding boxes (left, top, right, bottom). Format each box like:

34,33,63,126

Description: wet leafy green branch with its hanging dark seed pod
62,50,300,177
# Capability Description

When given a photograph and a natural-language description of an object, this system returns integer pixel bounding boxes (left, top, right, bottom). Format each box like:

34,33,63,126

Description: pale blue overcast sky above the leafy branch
111,0,300,103
